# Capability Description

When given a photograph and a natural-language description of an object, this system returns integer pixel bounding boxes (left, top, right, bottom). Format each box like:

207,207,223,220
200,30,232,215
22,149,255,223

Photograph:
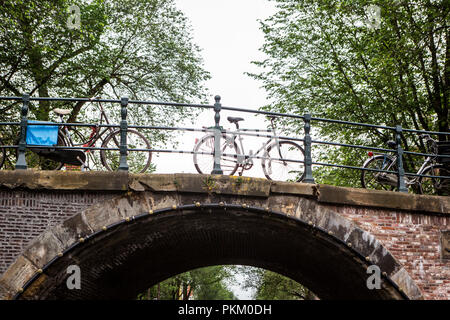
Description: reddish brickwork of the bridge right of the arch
333,206,450,300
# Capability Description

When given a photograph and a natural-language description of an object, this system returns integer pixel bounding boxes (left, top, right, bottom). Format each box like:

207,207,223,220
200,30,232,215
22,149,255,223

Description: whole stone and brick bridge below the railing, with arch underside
0,170,450,299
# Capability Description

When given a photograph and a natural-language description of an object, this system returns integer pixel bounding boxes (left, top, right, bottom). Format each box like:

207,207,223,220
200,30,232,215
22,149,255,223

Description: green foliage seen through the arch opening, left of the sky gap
138,266,236,300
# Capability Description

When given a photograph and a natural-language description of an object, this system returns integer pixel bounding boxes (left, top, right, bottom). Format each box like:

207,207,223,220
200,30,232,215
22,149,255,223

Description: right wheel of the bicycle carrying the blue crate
100,130,152,173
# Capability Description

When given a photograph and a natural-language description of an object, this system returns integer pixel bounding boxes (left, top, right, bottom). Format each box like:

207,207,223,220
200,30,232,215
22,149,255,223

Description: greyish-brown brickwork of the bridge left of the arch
0,190,117,275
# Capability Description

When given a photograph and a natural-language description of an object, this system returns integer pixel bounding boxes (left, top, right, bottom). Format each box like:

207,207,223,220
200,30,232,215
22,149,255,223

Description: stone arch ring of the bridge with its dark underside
0,191,422,299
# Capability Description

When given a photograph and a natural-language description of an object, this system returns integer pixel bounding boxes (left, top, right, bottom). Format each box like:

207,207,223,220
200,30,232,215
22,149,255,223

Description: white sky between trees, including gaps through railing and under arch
152,0,275,299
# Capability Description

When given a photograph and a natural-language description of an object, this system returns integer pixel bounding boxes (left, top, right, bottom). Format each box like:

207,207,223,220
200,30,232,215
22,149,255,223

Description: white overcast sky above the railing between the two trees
176,0,274,107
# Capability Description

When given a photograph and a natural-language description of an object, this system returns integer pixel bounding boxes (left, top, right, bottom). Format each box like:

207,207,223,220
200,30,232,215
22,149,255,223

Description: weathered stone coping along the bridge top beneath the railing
0,169,450,215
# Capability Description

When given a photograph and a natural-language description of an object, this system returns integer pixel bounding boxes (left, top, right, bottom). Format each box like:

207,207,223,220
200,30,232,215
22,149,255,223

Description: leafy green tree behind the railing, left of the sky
0,0,209,168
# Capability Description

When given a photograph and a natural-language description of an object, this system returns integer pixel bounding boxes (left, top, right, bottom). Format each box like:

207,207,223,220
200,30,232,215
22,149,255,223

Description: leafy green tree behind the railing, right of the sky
251,0,450,186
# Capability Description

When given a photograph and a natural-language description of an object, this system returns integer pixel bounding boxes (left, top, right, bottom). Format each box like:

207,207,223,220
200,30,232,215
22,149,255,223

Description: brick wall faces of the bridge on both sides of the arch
0,190,450,299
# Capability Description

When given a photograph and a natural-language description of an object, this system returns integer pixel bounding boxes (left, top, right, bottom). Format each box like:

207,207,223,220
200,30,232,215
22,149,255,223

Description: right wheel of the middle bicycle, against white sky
261,141,305,182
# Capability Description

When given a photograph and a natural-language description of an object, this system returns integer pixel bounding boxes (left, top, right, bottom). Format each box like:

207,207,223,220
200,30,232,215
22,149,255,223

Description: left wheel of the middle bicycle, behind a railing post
194,135,240,176
